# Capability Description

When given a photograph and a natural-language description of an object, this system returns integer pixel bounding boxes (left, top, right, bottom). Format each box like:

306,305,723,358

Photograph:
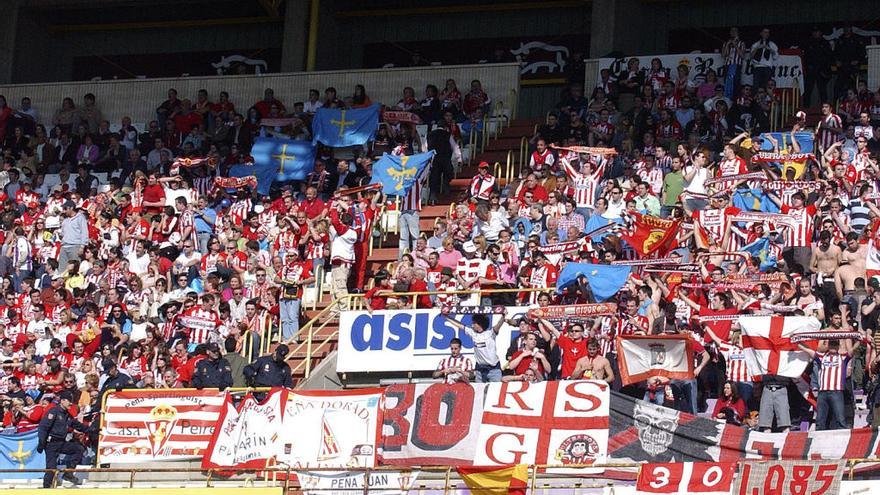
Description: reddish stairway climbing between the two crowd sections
288,119,543,388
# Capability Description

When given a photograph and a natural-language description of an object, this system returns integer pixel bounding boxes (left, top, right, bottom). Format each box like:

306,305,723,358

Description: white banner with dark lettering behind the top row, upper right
596,53,804,91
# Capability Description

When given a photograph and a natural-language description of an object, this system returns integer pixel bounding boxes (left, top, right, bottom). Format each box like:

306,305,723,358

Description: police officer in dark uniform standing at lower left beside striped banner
37,392,87,488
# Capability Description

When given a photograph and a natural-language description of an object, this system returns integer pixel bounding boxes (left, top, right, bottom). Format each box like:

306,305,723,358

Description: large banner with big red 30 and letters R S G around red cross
380,380,610,466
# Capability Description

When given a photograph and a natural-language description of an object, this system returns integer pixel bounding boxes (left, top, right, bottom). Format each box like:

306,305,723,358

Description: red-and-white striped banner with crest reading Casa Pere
98,389,226,463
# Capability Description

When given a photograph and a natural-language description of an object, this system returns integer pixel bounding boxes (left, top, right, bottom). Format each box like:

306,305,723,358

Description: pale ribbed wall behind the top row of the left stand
0,63,520,126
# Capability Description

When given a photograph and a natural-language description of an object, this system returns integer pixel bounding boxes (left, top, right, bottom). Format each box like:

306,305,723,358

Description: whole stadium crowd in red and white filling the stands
0,25,880,468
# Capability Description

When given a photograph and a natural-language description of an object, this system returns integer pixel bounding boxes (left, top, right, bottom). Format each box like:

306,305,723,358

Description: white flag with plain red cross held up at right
738,316,822,378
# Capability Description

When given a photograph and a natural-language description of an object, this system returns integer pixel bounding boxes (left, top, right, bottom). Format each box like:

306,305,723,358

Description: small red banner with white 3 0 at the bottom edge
636,462,736,494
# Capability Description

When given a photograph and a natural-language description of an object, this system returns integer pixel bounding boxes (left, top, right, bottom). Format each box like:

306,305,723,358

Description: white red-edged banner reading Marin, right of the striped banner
202,388,288,469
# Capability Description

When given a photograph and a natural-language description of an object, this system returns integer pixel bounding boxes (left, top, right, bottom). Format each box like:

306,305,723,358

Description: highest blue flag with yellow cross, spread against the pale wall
312,105,379,148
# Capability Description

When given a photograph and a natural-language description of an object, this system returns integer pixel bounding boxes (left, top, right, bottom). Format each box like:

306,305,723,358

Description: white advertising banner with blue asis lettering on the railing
336,306,529,373
